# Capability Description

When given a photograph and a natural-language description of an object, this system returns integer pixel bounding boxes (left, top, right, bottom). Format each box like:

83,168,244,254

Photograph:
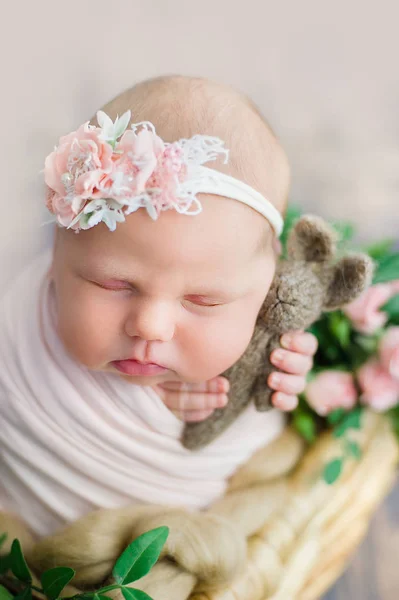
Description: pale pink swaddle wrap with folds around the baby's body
0,251,285,535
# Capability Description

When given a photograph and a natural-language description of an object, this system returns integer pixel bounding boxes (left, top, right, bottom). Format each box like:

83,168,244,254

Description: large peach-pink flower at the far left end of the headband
44,121,113,214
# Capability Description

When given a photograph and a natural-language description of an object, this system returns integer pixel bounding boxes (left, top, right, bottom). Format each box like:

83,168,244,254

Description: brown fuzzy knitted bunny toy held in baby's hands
182,215,373,450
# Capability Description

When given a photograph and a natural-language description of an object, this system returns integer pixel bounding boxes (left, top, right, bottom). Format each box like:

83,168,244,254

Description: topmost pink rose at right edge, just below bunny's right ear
343,280,399,334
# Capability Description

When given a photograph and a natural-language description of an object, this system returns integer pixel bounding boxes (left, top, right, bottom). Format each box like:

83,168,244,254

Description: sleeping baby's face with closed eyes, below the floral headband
52,196,276,385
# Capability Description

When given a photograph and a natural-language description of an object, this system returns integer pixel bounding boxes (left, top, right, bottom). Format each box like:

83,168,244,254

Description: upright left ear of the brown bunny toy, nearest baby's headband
287,215,338,263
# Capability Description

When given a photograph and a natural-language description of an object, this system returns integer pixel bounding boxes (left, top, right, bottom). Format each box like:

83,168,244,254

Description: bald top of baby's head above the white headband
92,76,290,212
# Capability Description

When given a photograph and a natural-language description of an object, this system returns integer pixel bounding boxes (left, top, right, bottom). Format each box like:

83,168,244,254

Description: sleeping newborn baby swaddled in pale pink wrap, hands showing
0,77,315,535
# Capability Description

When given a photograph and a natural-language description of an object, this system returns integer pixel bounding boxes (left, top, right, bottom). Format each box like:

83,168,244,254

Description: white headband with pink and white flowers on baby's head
44,110,283,236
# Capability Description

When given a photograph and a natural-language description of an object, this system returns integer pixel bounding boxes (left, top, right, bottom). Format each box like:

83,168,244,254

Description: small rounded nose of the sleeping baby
126,300,175,342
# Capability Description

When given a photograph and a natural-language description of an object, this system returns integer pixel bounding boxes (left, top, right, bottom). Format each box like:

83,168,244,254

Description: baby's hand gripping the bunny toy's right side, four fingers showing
267,331,317,411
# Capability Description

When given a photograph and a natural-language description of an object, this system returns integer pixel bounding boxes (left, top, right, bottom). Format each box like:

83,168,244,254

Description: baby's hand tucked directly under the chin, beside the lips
152,376,230,423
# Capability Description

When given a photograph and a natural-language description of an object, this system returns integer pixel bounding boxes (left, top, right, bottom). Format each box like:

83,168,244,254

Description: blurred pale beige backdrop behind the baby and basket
0,0,399,600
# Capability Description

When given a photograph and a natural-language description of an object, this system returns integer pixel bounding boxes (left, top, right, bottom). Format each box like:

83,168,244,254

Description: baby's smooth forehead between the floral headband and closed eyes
57,194,273,272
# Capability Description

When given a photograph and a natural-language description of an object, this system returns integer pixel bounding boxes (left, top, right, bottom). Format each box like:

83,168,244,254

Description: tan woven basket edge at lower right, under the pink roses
191,411,399,600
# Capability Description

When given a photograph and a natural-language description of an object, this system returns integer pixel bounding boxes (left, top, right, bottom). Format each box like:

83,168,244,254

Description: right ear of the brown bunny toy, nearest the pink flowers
324,254,373,310
